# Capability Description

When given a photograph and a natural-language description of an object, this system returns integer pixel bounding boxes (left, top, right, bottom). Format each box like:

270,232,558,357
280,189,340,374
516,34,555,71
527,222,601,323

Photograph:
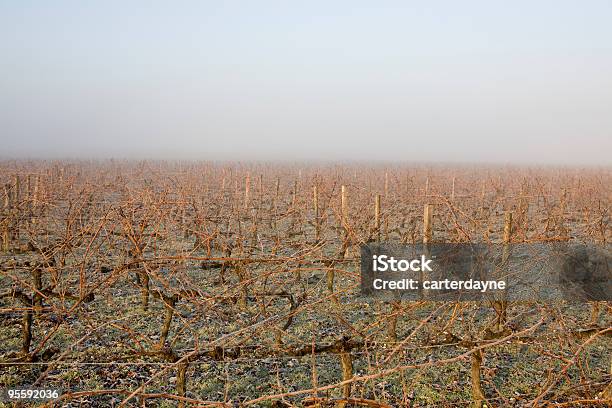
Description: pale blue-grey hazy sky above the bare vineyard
0,0,612,164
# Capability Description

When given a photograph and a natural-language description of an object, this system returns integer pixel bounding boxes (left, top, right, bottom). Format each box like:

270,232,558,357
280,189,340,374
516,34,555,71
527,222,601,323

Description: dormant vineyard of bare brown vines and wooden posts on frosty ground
0,161,612,407
